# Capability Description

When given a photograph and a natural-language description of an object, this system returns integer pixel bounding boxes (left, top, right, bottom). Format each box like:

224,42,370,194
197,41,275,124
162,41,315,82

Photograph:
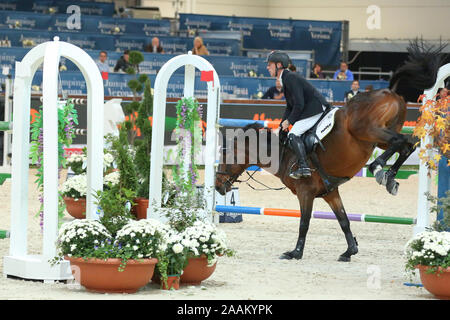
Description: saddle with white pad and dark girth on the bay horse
280,107,350,196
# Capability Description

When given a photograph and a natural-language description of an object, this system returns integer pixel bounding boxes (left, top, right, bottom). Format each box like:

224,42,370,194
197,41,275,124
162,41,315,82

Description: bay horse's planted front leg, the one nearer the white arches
280,193,314,260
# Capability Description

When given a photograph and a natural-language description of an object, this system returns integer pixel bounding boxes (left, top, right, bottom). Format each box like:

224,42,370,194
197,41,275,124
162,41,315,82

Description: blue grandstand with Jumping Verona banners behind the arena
0,0,402,101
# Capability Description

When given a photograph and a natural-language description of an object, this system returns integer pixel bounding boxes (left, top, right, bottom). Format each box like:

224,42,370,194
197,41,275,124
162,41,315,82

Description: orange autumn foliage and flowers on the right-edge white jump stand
413,95,450,170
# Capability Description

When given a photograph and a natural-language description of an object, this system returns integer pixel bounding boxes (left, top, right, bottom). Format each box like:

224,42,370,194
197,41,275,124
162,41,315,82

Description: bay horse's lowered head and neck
215,123,261,195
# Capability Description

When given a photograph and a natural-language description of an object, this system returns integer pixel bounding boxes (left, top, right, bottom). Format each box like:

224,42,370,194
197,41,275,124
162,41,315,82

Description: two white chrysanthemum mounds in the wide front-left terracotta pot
51,219,166,271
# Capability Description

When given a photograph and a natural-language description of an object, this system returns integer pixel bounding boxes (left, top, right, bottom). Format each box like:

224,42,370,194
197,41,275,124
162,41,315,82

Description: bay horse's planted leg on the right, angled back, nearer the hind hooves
323,189,358,262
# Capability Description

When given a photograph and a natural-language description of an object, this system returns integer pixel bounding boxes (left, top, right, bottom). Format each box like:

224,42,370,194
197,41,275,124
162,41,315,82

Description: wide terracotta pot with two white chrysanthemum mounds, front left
52,214,165,293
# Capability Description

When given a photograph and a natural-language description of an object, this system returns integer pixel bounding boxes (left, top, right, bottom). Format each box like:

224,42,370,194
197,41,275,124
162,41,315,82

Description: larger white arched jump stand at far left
3,37,104,282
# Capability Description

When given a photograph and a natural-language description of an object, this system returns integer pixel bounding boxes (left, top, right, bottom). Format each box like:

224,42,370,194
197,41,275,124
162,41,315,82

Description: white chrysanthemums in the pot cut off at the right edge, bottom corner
405,231,450,275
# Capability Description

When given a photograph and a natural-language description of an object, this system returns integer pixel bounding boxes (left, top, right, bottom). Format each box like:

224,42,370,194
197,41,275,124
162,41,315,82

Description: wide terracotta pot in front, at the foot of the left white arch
64,256,158,293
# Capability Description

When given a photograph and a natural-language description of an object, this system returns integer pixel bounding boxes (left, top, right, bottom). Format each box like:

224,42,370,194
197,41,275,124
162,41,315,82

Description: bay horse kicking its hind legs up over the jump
215,40,444,262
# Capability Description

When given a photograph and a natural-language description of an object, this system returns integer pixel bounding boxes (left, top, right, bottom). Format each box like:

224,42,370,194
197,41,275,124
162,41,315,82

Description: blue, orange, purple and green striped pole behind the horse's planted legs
216,205,416,225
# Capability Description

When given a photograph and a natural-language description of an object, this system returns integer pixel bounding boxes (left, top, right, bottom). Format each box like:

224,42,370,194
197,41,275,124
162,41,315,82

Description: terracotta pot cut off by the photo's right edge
416,265,450,300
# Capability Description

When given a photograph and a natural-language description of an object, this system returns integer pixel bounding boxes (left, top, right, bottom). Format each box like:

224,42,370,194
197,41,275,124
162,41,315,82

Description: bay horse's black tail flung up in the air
389,39,447,93
